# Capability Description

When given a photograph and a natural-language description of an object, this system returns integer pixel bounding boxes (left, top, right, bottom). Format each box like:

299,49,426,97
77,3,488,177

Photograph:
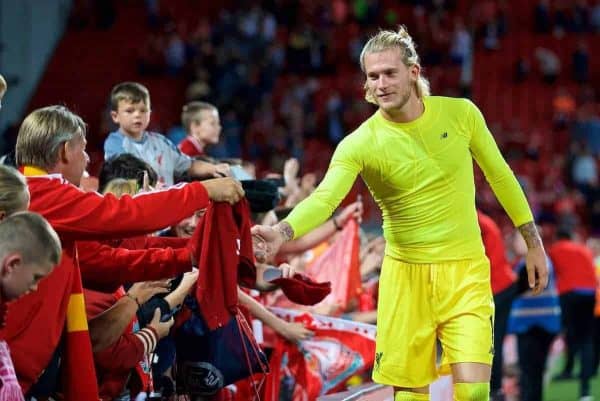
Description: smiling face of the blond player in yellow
364,48,419,115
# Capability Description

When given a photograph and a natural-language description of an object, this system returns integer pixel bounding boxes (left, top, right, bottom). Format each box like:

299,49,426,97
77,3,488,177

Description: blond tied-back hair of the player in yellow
360,25,431,104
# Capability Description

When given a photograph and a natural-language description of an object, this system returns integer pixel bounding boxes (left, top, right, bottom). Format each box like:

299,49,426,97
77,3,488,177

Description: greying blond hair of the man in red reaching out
15,106,85,170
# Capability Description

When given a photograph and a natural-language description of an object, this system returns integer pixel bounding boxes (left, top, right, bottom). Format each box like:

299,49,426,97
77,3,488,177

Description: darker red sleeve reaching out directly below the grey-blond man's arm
77,241,192,292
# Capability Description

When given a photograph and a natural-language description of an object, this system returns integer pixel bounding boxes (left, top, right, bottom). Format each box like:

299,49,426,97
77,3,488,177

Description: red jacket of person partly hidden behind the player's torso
477,211,517,295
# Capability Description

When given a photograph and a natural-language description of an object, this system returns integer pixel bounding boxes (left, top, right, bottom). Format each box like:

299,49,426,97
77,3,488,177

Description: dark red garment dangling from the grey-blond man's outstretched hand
191,199,256,330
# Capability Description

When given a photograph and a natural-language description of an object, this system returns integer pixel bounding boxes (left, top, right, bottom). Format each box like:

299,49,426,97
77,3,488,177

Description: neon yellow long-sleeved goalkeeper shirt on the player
285,96,533,263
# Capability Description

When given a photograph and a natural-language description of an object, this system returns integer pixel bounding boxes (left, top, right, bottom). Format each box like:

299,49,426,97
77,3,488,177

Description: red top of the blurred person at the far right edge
548,240,596,294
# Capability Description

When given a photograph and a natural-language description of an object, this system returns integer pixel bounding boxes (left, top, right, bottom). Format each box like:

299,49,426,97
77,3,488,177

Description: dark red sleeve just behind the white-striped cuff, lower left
94,333,144,373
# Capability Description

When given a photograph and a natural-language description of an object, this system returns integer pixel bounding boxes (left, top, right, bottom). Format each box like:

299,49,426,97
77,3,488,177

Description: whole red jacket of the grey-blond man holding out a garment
3,171,209,401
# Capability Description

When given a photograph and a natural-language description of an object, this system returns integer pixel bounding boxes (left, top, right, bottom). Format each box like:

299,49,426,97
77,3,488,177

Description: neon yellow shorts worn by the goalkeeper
373,256,494,388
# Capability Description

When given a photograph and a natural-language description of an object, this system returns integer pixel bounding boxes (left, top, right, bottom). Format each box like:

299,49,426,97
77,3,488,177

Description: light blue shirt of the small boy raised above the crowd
104,131,192,186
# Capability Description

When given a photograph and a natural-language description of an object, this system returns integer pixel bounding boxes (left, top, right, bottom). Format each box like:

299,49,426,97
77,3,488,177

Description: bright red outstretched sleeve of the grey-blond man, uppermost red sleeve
28,177,210,240
